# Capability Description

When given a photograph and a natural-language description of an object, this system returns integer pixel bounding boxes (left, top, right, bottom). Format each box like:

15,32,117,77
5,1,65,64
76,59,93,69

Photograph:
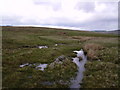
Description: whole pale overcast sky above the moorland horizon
0,0,118,31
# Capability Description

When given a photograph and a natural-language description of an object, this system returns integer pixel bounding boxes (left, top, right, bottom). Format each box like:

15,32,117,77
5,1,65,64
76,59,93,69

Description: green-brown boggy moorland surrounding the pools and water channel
2,27,120,88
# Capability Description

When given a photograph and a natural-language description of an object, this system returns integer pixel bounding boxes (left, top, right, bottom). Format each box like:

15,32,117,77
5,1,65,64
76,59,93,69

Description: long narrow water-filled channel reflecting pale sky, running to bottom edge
70,49,87,88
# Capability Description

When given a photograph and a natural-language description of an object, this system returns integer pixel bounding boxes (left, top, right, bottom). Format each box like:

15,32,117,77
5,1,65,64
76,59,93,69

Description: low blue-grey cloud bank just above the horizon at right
51,15,118,30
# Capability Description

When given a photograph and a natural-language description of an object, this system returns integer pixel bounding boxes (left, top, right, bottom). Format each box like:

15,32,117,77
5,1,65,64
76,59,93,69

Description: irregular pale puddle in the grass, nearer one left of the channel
20,63,48,71
